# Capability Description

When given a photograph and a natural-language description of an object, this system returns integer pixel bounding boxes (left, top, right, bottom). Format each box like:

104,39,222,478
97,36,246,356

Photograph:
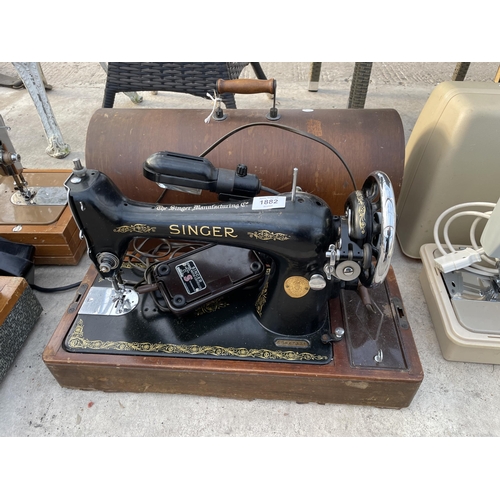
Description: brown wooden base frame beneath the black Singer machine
43,267,423,408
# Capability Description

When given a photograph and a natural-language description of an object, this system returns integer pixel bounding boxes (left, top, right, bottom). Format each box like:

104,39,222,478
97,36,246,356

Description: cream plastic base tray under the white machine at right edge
420,243,500,364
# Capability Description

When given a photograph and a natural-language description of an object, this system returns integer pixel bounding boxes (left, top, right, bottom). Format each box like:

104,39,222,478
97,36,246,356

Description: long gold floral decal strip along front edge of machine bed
68,319,328,361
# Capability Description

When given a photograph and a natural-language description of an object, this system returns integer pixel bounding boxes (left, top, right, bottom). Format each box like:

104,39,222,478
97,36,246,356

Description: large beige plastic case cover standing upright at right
397,82,500,259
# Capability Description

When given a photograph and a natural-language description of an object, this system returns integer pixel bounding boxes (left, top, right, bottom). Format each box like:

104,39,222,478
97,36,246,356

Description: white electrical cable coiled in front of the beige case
434,202,499,277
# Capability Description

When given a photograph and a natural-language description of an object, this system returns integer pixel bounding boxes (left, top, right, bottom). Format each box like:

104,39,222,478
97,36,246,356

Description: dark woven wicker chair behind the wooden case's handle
102,62,265,109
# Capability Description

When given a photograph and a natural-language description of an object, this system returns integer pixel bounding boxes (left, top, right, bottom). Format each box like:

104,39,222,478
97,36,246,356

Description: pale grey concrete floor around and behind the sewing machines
0,62,500,437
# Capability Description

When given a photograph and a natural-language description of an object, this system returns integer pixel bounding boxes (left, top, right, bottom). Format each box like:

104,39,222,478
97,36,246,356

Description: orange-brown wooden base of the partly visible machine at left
0,169,86,265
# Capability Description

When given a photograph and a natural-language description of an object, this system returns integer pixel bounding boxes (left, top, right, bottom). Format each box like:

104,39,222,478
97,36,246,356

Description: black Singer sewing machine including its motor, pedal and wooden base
43,109,423,408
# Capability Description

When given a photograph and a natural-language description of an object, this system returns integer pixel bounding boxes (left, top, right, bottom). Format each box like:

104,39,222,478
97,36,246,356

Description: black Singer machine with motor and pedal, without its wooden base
61,148,396,363
